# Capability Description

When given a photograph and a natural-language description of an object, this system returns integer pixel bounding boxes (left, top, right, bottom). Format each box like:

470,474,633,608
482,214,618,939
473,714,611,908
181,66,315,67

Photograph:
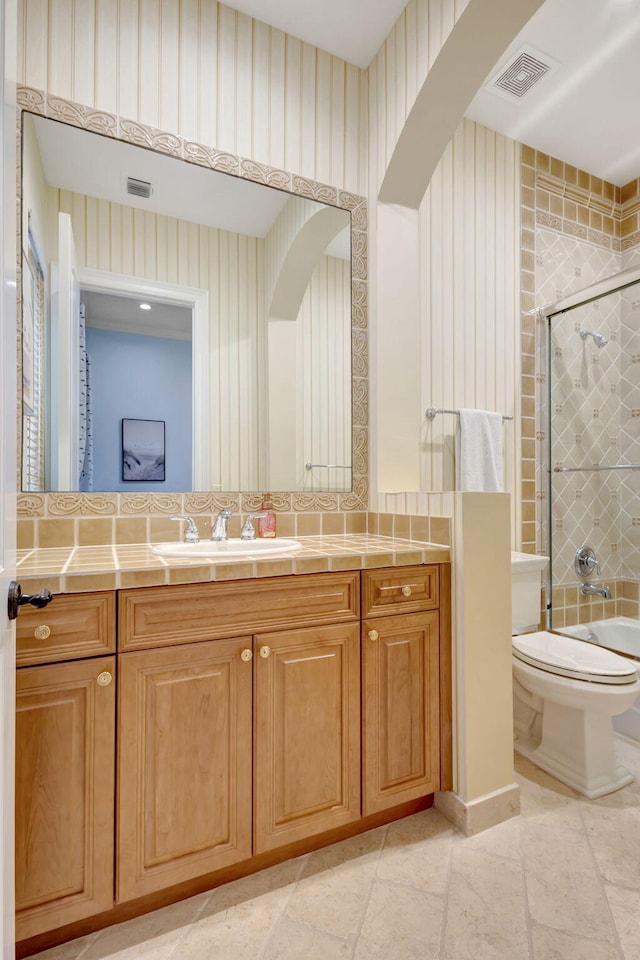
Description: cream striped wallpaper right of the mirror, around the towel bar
369,9,520,543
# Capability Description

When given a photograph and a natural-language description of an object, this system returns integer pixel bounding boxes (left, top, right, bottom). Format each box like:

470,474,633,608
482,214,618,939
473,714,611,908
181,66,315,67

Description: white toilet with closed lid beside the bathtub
511,553,640,799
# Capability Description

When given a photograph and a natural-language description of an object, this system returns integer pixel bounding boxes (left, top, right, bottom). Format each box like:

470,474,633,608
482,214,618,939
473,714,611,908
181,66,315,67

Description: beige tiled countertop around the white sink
17,534,451,593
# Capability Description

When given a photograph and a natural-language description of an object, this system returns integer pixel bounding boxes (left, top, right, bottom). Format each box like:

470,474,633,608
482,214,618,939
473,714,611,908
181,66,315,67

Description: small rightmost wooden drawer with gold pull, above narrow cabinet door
362,564,440,617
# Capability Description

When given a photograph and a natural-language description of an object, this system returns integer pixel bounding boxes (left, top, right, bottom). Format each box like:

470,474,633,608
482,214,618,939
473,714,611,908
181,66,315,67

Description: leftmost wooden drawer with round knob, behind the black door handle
16,592,116,667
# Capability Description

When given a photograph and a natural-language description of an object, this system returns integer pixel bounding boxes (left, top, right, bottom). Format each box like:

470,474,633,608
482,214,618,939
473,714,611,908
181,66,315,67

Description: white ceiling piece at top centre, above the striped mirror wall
219,0,410,67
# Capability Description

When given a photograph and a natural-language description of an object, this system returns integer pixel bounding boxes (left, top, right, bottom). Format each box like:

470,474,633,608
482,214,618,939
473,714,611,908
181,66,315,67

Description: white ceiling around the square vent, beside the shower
467,0,640,186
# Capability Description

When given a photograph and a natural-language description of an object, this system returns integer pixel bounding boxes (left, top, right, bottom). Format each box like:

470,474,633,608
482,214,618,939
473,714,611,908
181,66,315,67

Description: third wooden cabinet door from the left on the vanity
254,624,360,853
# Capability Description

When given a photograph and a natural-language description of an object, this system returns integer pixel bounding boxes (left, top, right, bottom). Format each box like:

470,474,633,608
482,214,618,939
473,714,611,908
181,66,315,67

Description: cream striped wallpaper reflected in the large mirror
49,188,351,490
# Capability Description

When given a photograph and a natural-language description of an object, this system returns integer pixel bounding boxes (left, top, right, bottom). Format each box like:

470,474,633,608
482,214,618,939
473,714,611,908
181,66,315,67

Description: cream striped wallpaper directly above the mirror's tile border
18,0,367,194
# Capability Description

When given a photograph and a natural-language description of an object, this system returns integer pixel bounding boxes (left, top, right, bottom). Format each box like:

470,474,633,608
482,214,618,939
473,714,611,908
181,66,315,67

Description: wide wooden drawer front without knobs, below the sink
118,571,360,651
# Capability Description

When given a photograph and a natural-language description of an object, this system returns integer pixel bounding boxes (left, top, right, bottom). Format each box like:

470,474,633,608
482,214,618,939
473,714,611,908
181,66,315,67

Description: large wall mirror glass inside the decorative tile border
20,101,366,494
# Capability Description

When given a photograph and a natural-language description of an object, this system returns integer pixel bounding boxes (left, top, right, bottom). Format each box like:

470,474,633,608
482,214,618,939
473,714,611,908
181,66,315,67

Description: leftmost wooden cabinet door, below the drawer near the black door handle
16,657,116,940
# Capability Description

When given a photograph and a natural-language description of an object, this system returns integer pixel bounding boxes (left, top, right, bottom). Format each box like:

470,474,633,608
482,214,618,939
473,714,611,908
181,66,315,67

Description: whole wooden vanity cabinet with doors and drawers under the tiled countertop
16,564,451,956
